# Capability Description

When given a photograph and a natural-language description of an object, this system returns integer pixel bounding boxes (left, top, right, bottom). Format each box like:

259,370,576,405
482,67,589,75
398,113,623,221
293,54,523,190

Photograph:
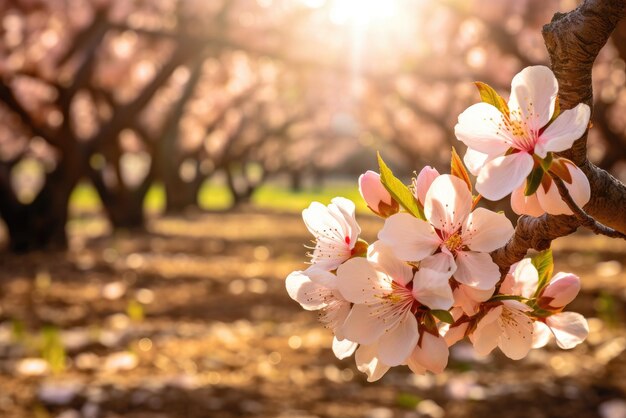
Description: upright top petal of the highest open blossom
509,65,559,132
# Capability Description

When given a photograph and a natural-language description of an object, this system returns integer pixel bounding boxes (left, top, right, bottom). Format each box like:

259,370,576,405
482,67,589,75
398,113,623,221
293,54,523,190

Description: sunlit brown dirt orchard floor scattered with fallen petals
0,211,626,418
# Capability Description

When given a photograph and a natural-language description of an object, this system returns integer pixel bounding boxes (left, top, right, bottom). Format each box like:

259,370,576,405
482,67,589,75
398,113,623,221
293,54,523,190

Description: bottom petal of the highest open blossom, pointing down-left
476,152,534,200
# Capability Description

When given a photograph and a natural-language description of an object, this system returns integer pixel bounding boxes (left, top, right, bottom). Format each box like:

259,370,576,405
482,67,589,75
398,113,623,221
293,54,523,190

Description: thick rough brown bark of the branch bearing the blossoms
492,0,626,273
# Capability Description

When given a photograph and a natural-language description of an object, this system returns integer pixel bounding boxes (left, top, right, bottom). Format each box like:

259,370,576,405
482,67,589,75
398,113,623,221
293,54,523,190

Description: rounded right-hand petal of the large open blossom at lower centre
413,268,454,310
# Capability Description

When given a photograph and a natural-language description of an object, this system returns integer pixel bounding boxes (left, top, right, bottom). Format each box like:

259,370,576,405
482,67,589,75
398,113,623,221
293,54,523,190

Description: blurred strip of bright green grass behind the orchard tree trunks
70,182,369,213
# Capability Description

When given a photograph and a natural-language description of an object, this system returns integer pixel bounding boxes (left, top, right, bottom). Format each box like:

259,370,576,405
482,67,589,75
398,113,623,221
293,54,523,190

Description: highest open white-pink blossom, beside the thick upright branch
455,66,590,200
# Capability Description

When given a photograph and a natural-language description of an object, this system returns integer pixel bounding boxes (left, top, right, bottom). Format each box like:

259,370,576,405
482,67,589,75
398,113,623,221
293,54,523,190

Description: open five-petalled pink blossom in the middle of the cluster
378,174,514,290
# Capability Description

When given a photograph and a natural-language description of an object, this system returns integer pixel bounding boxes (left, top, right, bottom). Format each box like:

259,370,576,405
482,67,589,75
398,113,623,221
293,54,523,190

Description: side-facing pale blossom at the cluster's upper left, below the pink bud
302,197,361,271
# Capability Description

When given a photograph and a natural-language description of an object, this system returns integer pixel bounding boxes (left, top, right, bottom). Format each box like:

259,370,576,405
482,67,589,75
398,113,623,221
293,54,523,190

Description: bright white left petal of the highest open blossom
454,102,513,155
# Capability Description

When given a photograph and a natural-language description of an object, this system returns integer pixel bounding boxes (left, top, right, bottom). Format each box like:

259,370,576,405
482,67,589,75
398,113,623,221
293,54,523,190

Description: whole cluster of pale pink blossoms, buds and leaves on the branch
286,67,589,381
